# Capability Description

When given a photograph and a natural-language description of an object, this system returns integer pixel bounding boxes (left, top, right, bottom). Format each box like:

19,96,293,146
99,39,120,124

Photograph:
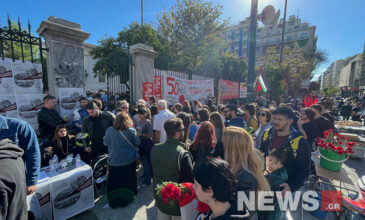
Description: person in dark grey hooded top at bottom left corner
0,139,28,220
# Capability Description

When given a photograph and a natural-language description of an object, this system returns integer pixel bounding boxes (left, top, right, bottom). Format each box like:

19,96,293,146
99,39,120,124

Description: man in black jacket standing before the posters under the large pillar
38,95,67,139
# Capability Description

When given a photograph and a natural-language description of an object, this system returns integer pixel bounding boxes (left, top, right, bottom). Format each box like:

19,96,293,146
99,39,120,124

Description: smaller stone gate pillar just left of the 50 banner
129,43,158,102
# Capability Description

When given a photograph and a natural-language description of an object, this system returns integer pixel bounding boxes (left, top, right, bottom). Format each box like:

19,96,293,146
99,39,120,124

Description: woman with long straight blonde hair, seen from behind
223,126,270,195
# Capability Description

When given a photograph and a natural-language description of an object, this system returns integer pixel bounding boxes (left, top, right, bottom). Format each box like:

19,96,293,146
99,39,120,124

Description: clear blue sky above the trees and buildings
0,0,365,79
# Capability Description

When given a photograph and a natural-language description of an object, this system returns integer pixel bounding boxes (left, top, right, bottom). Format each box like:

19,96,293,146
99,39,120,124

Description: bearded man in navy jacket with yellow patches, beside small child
260,107,311,193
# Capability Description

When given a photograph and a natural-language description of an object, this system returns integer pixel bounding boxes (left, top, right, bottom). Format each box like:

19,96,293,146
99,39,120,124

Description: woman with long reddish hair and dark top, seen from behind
189,121,223,163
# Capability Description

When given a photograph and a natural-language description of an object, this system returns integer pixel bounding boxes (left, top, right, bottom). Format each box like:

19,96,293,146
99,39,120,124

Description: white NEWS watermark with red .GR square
237,191,342,212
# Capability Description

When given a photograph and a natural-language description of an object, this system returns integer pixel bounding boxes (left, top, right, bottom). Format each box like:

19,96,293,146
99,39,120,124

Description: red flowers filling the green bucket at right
317,129,355,155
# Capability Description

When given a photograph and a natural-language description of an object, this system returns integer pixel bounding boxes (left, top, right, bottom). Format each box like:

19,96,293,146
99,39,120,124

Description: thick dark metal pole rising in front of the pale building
247,0,258,100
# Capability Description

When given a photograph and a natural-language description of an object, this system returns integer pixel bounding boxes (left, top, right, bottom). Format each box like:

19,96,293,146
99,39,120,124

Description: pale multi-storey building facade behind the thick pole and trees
222,15,317,64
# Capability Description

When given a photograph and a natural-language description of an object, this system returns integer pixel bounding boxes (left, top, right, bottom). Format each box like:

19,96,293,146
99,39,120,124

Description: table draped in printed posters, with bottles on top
27,162,95,220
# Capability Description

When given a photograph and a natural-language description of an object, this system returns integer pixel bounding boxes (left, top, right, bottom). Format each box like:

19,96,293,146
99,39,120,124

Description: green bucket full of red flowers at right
317,129,355,171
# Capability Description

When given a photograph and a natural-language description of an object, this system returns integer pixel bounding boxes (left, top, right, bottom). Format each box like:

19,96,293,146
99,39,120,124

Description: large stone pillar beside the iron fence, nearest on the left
37,16,90,97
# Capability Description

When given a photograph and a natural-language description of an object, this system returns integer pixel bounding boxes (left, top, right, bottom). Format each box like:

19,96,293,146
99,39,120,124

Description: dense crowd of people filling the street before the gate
0,91,365,219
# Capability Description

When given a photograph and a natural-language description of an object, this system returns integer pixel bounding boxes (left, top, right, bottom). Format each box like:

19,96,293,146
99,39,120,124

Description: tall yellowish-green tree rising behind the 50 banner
158,0,226,76
